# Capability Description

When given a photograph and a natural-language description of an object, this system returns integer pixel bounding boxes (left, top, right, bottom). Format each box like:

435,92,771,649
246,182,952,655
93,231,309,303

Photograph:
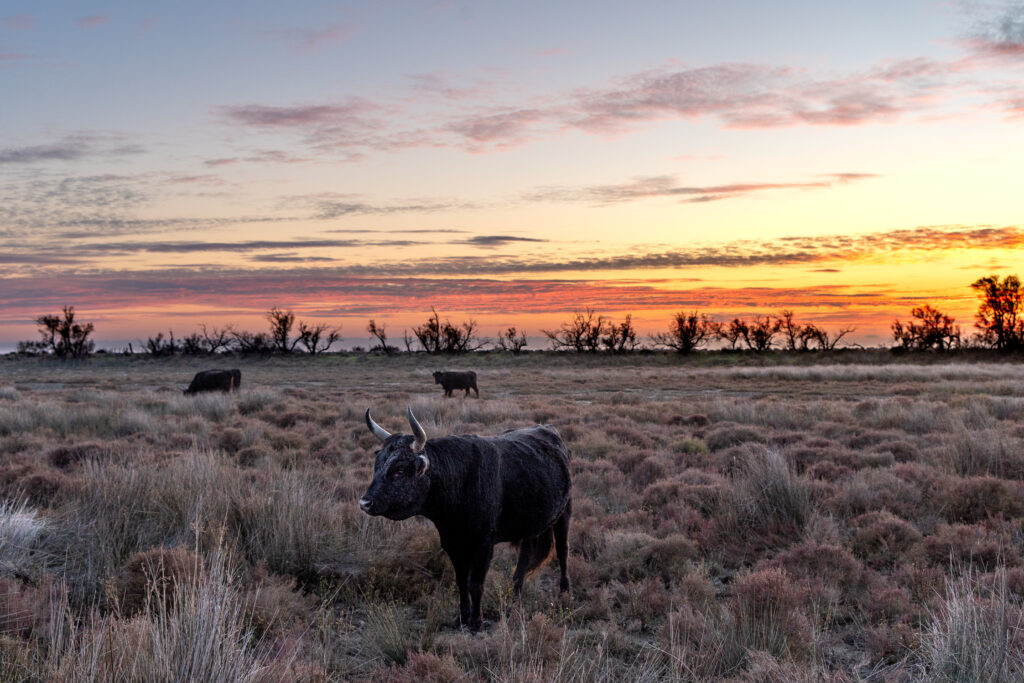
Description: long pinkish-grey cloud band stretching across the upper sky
222,52,958,159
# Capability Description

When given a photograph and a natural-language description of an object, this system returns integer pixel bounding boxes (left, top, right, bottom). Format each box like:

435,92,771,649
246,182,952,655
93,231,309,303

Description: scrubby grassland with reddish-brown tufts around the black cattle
0,352,1024,681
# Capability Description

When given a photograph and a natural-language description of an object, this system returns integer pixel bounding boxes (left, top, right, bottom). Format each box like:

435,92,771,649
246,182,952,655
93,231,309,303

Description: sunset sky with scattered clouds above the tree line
0,0,1024,345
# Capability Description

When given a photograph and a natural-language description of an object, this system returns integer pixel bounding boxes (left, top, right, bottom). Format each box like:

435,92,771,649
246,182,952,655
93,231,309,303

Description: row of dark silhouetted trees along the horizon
17,275,1024,358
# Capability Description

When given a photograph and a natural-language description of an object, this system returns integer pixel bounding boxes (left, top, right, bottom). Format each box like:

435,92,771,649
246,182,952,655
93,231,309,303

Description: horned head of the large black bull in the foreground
359,408,430,519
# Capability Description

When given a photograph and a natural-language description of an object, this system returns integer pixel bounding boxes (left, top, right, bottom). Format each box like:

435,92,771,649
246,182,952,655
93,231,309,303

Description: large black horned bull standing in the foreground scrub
359,409,572,631
